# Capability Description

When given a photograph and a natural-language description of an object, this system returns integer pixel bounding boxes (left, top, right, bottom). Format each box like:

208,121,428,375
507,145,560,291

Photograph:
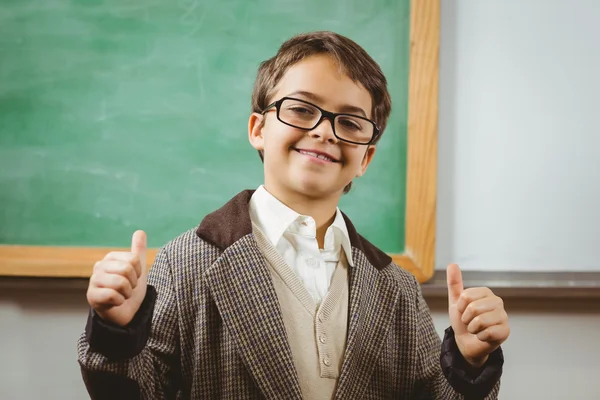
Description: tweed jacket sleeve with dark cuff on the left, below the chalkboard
77,248,181,400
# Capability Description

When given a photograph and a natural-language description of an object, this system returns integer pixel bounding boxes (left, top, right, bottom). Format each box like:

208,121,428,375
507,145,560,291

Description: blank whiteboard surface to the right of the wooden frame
436,0,600,271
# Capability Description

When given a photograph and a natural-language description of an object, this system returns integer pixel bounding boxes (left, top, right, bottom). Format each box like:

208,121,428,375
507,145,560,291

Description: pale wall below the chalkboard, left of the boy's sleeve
0,286,89,400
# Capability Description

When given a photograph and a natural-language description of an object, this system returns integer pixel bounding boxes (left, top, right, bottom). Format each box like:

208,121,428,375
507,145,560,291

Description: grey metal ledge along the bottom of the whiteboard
421,270,600,299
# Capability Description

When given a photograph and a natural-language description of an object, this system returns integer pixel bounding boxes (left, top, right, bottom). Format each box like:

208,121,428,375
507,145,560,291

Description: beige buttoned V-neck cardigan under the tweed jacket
252,225,348,400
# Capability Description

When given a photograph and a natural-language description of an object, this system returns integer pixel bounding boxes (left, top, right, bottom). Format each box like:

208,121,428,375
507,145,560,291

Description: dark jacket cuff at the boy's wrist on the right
440,327,504,399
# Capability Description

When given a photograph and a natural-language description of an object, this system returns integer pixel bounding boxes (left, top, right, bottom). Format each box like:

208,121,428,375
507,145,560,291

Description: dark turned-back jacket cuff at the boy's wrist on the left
85,285,156,361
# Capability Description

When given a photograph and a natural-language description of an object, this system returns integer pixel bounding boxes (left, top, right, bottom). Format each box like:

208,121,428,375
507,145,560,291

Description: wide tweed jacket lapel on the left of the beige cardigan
204,234,302,399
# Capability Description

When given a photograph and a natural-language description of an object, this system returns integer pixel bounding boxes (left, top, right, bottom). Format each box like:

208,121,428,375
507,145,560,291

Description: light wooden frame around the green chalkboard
0,0,440,282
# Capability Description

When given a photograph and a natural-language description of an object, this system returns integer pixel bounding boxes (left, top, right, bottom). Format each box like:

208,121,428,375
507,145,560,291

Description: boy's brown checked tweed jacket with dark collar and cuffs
78,191,503,400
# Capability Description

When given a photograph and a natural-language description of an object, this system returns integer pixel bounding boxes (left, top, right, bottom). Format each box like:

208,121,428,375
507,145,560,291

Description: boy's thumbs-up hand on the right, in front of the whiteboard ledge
446,264,510,367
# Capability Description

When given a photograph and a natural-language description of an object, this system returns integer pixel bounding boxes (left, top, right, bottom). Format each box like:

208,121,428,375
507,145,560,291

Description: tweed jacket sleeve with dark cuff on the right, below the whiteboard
414,280,504,400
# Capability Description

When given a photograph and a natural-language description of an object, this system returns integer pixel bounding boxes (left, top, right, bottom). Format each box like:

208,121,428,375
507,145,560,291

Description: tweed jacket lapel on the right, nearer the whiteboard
335,248,400,399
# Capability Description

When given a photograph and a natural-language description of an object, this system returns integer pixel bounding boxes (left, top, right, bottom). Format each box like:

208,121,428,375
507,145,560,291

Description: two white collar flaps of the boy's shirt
250,185,354,266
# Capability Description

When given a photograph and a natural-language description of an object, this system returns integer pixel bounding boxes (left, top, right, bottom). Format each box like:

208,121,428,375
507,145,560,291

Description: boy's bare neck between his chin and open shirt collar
265,183,341,249
